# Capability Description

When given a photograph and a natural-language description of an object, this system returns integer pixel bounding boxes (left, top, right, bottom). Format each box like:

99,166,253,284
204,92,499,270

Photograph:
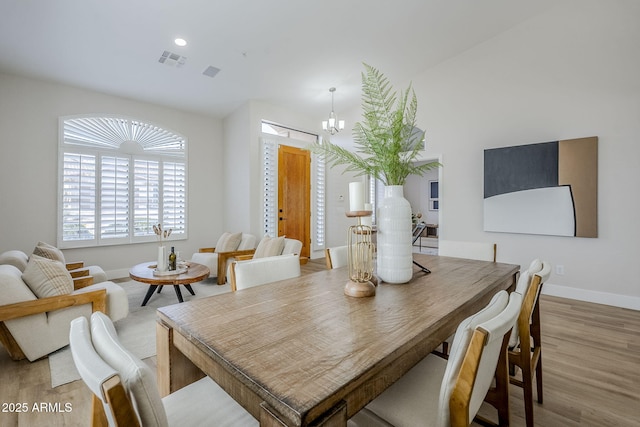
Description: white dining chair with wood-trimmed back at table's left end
69,312,258,427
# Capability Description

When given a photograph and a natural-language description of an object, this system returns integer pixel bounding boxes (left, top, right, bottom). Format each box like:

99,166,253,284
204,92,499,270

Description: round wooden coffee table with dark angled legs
129,261,209,306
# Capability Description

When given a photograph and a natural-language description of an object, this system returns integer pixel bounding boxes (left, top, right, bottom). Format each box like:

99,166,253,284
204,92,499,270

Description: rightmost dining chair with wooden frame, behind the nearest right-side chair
509,259,551,427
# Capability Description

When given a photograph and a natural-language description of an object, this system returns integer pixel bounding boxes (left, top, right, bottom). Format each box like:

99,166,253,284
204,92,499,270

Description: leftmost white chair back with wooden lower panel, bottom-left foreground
69,317,140,426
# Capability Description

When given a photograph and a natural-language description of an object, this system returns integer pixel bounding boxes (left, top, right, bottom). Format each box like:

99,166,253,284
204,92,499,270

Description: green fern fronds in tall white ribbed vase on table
313,64,440,283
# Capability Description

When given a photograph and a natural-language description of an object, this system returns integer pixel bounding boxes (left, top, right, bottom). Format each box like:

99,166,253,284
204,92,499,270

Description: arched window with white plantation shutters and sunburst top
58,116,187,248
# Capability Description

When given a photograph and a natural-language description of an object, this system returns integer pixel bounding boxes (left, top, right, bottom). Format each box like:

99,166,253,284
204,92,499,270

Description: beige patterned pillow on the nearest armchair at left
22,255,73,298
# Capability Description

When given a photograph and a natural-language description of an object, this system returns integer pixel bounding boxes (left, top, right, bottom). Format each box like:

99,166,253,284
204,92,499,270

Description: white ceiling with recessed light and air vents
0,0,557,120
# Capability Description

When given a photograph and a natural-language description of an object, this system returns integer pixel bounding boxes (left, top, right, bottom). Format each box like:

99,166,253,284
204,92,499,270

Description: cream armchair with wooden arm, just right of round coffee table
191,232,257,285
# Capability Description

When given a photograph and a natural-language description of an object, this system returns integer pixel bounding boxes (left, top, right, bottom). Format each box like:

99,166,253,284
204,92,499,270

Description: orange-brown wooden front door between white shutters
278,145,311,257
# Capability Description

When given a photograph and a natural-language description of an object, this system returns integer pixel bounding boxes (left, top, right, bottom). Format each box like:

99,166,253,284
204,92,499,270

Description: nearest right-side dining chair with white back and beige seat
349,291,522,427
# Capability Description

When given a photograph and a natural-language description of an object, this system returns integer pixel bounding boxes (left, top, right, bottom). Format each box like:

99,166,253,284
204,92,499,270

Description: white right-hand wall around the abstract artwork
413,0,640,309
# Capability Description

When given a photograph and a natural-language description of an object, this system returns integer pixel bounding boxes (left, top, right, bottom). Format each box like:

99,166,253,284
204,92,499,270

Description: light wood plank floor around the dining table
0,260,640,427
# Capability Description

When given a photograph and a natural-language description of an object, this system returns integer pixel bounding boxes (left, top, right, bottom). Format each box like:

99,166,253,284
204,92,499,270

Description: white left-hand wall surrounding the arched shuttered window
0,74,223,277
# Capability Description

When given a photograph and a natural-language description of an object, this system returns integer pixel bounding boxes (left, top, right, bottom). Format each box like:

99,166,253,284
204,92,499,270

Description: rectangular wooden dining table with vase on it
157,254,519,426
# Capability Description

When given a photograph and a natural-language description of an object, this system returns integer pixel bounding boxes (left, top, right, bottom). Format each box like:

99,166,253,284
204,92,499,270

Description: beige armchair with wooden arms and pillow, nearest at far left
0,256,129,361
